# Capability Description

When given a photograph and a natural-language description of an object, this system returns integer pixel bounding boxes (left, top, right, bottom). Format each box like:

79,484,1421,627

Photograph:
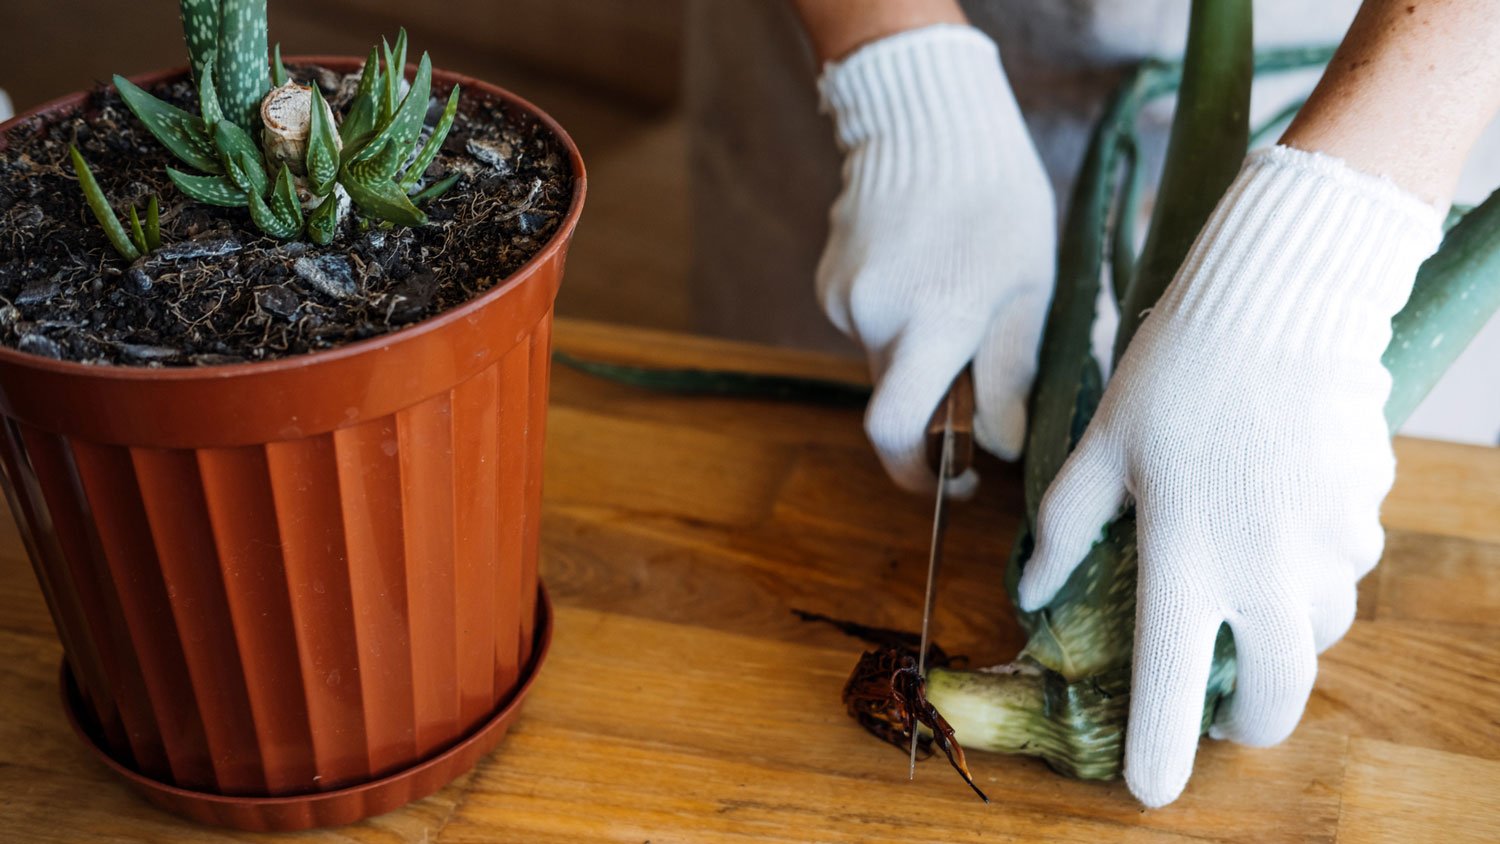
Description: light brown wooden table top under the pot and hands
0,321,1500,844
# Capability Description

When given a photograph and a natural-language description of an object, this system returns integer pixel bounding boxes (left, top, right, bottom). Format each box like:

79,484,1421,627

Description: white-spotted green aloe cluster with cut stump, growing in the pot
96,0,459,247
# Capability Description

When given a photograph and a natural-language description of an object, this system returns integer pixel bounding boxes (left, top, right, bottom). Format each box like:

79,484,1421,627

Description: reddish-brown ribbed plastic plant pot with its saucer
0,57,585,831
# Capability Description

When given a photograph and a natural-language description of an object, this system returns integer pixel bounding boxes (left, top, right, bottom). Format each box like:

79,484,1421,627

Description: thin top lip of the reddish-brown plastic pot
0,54,588,382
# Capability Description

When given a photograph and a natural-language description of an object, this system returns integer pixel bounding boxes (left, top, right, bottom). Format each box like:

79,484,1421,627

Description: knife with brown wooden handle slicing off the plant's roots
906,367,974,780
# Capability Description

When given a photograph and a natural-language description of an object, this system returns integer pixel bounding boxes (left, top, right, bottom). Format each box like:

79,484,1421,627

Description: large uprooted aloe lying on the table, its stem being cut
906,0,1500,778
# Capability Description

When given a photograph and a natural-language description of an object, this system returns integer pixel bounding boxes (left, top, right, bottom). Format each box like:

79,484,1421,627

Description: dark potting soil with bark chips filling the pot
0,67,573,366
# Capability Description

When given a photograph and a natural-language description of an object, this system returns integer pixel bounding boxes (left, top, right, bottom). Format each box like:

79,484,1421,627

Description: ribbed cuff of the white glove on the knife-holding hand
818,24,1031,183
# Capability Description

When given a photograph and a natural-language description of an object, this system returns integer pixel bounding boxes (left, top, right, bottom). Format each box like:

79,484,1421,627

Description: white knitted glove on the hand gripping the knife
818,25,1056,495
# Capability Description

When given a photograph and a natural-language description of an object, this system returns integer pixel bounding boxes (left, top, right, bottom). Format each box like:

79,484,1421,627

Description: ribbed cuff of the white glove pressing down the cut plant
1160,145,1443,357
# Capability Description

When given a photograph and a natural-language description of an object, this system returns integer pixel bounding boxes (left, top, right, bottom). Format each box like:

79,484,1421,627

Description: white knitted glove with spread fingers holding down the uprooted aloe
1020,147,1442,807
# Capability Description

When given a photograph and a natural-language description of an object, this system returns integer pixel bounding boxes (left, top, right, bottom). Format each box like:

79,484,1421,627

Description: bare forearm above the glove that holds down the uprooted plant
1281,0,1500,204
